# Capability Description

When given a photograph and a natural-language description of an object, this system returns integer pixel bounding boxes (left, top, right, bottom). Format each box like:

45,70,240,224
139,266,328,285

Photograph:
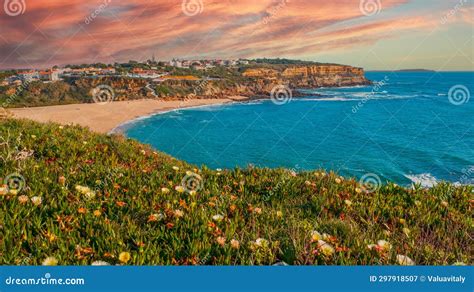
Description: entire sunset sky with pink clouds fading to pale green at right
0,0,474,70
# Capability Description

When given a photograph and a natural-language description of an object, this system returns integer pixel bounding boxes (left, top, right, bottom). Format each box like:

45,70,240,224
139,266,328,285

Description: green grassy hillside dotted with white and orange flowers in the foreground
0,119,473,265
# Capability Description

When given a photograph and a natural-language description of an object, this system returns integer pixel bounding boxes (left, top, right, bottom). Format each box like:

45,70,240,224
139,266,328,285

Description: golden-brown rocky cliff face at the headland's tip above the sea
242,65,371,88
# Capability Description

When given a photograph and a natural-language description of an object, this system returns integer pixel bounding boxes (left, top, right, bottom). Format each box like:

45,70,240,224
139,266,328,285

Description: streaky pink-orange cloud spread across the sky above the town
0,0,460,68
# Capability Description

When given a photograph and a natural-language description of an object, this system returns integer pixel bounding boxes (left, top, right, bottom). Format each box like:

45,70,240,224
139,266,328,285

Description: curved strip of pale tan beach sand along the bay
9,96,247,133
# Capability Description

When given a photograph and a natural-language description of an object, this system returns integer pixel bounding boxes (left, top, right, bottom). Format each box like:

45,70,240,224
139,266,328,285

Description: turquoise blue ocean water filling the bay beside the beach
125,72,474,186
